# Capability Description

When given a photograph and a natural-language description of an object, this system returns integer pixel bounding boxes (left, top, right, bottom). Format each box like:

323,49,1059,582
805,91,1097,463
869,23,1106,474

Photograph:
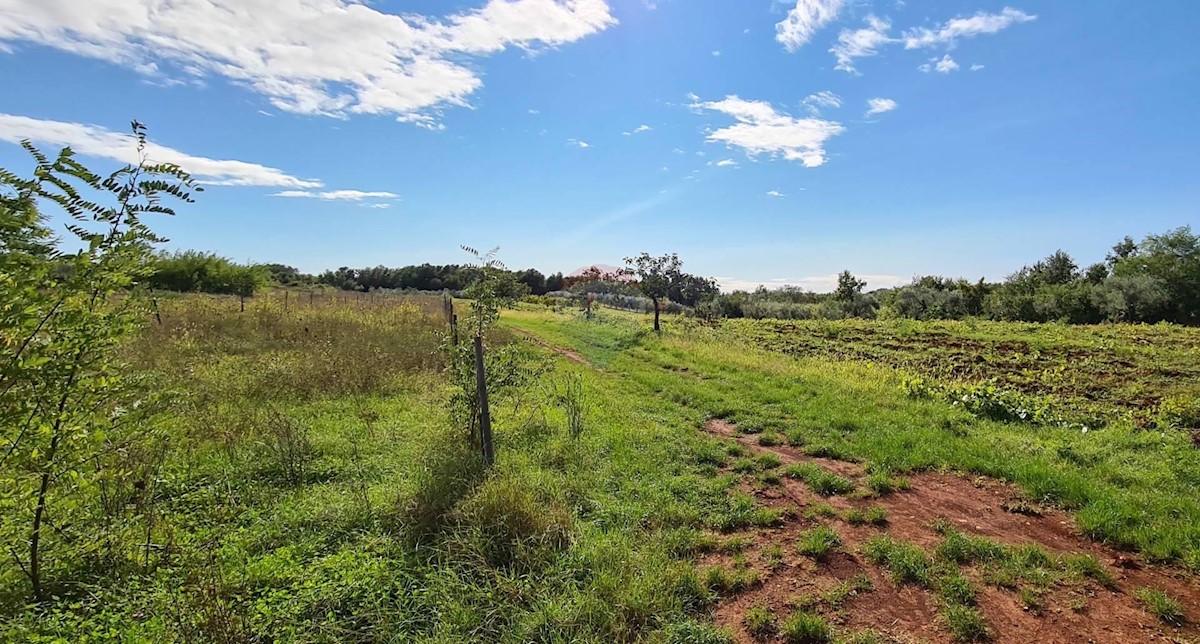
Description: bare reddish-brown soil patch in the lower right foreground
701,421,1200,644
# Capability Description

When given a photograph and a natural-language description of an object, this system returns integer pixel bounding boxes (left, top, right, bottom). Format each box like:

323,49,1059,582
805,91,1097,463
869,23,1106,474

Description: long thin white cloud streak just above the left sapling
0,114,324,188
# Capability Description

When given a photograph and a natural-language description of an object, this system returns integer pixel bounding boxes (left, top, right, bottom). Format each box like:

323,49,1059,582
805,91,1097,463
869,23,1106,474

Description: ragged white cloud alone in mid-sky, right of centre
691,95,845,168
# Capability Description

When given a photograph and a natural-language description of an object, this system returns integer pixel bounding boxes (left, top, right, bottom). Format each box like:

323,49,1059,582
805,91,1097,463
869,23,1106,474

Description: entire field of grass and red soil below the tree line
0,296,1200,643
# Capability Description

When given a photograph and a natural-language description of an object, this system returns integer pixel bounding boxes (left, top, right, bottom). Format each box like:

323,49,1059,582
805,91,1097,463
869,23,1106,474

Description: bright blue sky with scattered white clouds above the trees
0,0,1200,290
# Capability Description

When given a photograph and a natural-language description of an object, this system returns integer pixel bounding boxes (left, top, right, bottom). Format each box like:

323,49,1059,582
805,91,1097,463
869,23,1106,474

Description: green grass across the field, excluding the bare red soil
18,297,1200,642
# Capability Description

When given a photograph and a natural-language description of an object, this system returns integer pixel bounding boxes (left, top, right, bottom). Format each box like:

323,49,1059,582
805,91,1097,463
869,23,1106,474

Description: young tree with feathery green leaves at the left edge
0,122,198,601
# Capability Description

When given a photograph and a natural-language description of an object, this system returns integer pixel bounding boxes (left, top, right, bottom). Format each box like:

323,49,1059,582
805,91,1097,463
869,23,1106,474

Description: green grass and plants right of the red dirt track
509,312,1200,570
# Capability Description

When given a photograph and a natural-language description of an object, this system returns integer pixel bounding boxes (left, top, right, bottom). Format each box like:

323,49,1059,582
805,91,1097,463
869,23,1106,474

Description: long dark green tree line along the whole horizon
149,227,1200,325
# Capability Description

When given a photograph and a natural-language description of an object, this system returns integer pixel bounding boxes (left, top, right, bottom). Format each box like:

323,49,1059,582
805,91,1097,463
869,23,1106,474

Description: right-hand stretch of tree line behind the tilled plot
697,227,1200,325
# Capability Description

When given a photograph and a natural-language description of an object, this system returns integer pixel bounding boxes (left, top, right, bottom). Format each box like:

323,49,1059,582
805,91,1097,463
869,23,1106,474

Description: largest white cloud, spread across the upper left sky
0,0,617,128
